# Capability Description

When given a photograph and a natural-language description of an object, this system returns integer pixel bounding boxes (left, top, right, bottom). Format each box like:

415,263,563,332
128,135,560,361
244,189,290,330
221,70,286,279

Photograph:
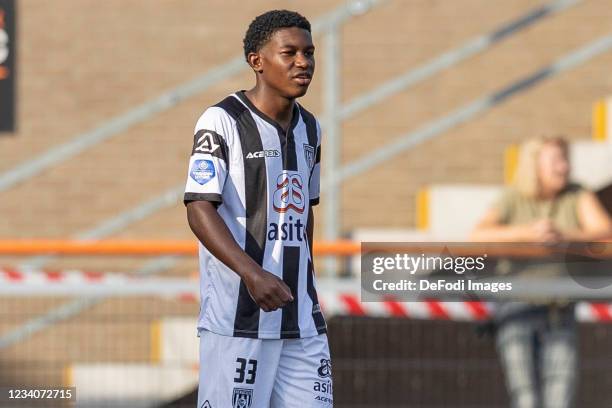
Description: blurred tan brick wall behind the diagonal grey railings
0,0,612,244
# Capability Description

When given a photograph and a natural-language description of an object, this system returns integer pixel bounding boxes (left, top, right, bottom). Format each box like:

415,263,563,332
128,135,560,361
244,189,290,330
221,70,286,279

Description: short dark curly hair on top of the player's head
242,10,310,59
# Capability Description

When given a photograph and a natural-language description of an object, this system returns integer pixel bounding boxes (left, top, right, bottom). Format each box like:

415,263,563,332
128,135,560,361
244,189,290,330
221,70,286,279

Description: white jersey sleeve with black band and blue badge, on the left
183,108,232,205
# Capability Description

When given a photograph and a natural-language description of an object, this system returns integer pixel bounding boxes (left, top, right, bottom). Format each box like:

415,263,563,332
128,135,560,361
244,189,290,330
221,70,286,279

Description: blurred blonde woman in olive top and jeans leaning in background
470,137,612,408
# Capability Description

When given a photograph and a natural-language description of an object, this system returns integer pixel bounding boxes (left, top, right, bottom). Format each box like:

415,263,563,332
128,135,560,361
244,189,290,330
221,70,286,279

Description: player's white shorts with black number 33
198,331,333,408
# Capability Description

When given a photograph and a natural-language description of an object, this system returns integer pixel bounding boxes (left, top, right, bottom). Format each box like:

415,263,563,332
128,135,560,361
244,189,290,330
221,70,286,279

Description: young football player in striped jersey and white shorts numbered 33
185,10,333,408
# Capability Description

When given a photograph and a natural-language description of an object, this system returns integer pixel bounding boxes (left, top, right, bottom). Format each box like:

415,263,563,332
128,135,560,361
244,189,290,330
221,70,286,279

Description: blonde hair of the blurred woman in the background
513,136,568,197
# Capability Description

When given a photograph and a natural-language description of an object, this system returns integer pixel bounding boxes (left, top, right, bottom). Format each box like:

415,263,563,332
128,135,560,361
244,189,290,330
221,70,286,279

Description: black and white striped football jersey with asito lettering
184,91,326,339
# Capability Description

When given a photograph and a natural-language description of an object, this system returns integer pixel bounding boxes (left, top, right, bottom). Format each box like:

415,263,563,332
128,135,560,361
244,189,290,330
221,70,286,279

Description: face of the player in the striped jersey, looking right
259,27,315,99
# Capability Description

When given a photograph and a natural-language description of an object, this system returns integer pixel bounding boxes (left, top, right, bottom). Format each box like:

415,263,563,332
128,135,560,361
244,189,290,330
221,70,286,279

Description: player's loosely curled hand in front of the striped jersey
244,269,293,312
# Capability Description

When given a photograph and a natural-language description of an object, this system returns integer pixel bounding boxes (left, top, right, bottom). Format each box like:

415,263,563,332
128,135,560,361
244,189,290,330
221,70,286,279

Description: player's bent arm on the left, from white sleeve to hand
184,108,293,312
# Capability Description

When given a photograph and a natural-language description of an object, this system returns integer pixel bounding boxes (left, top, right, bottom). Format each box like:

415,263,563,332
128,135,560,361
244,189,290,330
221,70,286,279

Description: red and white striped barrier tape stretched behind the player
0,268,612,322
